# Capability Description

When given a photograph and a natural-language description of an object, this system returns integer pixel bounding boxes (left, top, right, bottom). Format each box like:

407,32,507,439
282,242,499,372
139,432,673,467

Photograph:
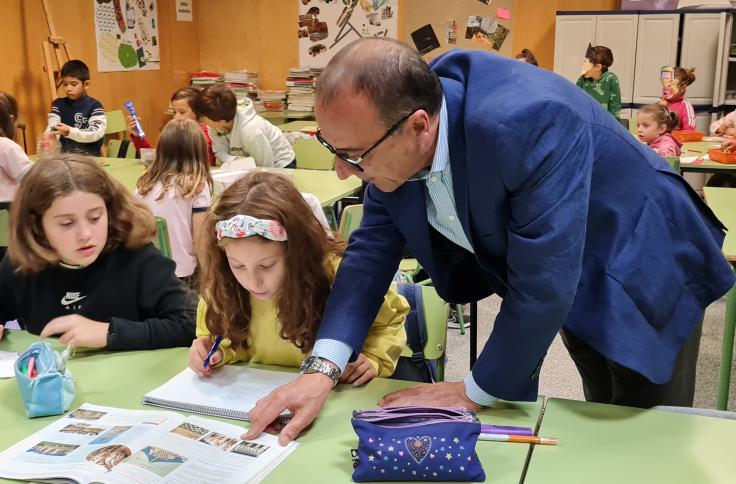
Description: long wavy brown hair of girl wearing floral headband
200,171,345,352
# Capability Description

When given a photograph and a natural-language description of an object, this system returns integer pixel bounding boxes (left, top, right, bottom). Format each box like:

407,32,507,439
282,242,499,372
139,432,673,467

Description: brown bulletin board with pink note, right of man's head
400,0,516,61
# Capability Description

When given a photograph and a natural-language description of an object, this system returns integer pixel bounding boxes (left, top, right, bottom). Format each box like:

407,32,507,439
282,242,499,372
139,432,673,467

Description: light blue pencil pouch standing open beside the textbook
15,341,75,418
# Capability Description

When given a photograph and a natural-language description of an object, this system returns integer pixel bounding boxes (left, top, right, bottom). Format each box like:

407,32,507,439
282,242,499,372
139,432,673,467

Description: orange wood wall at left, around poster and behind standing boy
0,0,200,153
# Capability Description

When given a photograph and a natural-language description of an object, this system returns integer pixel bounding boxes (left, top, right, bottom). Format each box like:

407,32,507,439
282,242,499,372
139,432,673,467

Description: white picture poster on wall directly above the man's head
296,0,399,67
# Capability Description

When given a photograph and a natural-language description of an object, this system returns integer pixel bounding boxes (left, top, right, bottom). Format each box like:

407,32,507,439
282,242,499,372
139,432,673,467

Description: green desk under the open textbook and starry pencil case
0,331,548,484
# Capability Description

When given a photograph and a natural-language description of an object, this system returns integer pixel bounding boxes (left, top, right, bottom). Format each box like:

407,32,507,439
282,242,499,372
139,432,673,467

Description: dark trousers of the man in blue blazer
560,321,703,408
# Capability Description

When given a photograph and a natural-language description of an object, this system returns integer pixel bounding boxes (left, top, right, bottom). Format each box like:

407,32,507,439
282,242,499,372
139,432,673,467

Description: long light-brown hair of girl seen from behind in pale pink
136,119,212,200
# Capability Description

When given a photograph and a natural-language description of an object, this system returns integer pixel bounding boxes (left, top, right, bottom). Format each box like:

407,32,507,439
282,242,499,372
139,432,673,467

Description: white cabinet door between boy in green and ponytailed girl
634,13,680,104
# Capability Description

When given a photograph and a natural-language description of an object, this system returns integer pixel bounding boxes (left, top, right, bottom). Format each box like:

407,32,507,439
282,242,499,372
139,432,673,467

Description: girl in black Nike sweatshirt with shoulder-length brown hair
0,153,194,350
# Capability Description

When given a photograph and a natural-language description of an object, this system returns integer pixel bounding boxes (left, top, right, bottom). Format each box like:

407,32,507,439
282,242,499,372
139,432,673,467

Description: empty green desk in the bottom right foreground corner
524,398,736,484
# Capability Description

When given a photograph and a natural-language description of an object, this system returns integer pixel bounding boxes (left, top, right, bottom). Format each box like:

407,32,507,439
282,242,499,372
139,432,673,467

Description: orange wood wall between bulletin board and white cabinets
511,0,621,69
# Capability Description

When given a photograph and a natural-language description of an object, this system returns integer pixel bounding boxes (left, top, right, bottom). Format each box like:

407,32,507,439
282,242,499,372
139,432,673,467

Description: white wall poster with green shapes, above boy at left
92,0,161,72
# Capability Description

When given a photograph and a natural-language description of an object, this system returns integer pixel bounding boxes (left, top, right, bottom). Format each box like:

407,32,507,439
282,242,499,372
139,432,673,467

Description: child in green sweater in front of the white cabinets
576,45,621,119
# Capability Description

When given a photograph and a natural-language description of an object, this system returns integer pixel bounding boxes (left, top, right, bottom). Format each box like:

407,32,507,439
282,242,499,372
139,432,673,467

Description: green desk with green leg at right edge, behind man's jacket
703,187,736,410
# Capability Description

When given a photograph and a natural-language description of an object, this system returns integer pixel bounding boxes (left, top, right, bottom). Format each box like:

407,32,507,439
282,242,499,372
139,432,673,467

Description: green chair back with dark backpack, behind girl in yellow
391,284,450,381
